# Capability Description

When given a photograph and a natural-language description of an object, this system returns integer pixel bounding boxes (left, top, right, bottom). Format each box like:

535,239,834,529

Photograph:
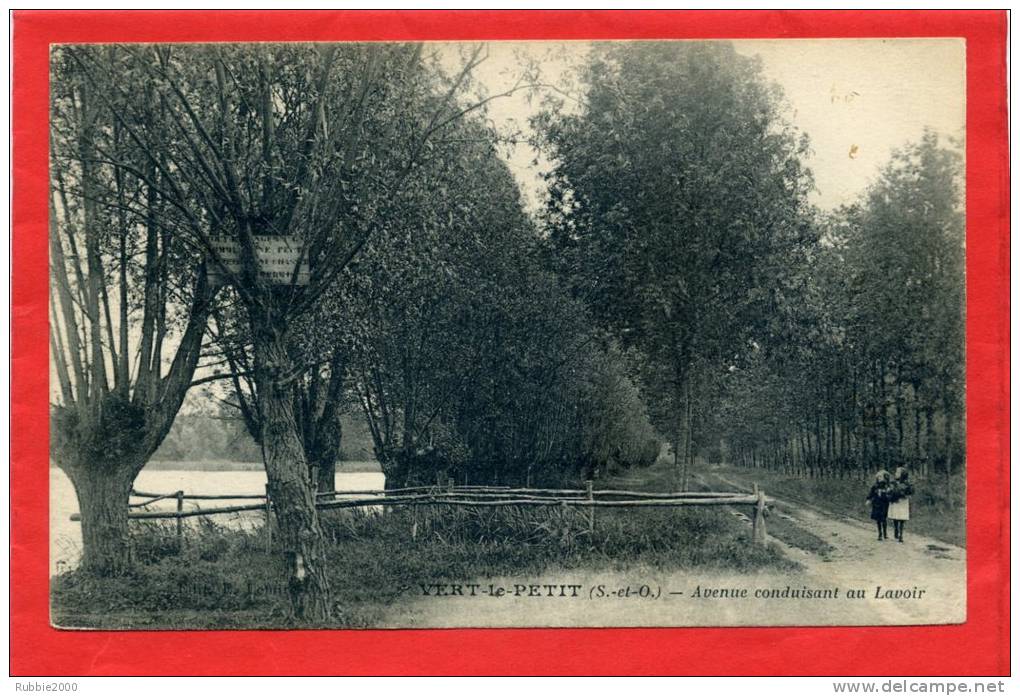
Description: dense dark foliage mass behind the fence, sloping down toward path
336,116,658,487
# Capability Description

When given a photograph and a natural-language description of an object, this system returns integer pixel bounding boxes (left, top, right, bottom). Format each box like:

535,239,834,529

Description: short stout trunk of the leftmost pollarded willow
64,462,138,576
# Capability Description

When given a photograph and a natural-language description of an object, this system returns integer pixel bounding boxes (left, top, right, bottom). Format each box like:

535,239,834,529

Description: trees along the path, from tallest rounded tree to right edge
538,42,965,486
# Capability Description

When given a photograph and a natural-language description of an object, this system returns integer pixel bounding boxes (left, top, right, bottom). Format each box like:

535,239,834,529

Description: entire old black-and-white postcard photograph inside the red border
47,38,966,631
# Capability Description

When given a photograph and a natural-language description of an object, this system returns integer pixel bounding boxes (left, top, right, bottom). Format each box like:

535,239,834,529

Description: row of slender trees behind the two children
708,132,965,485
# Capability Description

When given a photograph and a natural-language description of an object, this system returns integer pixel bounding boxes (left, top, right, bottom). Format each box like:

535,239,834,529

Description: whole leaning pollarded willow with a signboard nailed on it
61,44,534,620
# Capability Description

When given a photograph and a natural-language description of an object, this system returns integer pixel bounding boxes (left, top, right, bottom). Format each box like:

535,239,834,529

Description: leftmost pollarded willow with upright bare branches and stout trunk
49,47,215,574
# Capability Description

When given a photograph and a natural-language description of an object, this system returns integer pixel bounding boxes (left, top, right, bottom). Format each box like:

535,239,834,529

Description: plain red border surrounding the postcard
10,10,1009,676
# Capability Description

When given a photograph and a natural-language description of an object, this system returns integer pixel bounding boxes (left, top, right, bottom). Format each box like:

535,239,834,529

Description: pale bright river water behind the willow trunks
50,466,385,575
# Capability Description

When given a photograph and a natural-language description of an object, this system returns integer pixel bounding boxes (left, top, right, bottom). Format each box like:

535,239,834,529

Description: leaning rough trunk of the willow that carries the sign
253,327,333,622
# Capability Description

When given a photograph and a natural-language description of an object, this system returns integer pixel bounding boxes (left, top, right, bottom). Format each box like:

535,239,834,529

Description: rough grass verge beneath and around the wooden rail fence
51,498,797,629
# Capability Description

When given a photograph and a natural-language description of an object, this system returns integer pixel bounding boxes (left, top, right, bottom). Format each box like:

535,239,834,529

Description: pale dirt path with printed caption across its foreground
375,463,966,627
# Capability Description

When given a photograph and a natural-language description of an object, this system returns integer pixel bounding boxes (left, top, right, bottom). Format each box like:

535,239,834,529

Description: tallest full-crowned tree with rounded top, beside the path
536,42,812,485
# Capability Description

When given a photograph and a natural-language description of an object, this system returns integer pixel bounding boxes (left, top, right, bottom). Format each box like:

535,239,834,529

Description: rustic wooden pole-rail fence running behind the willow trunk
70,481,768,544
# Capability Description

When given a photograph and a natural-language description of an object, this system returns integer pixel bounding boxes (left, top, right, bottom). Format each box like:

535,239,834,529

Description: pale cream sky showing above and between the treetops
440,39,966,209
